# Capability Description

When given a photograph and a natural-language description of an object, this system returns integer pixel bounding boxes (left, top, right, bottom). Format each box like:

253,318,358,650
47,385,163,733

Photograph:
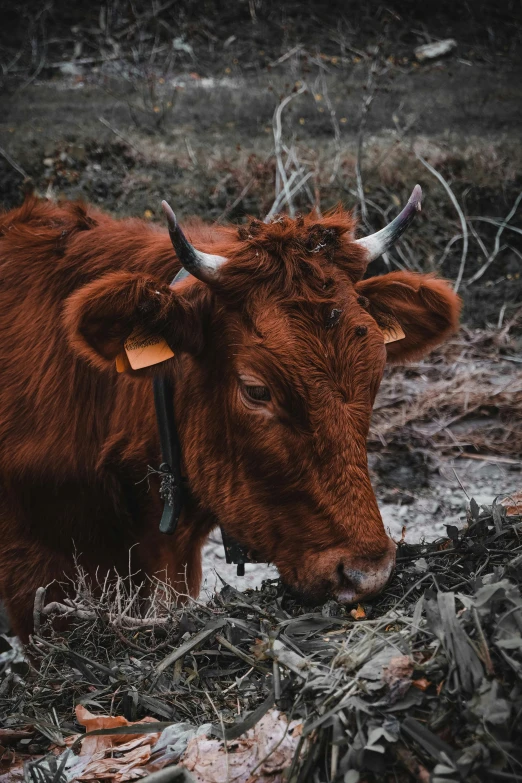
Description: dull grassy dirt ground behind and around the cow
0,0,522,588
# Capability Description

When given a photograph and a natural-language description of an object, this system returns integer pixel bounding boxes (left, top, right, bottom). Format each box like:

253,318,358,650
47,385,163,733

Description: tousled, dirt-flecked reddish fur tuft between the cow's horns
205,208,366,305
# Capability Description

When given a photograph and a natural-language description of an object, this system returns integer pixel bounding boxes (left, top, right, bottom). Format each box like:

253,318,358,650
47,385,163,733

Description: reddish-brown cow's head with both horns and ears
67,188,459,603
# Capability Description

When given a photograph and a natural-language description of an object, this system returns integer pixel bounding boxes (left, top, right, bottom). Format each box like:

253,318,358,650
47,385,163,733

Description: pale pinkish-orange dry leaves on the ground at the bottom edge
29,705,303,783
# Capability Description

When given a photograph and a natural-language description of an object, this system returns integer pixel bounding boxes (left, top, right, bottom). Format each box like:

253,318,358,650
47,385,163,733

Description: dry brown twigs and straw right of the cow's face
370,328,522,457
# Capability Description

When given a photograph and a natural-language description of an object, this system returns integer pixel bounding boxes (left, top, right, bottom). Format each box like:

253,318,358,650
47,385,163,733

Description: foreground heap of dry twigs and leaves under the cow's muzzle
0,501,522,783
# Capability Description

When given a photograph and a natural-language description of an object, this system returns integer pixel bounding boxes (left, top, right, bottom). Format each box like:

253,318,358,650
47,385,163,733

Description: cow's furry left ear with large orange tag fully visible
64,272,206,371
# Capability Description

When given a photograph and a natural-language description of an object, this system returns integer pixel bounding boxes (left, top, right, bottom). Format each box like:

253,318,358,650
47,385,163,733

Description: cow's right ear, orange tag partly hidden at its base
355,272,461,362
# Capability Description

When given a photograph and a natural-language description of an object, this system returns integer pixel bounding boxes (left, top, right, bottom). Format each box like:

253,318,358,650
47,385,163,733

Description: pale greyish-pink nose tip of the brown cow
335,540,396,604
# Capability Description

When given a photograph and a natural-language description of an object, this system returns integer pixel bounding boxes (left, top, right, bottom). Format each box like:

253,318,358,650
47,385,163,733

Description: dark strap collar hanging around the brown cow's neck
152,267,258,576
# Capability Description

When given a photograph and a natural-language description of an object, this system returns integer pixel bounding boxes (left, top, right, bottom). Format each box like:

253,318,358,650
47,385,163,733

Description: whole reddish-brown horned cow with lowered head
0,189,459,638
